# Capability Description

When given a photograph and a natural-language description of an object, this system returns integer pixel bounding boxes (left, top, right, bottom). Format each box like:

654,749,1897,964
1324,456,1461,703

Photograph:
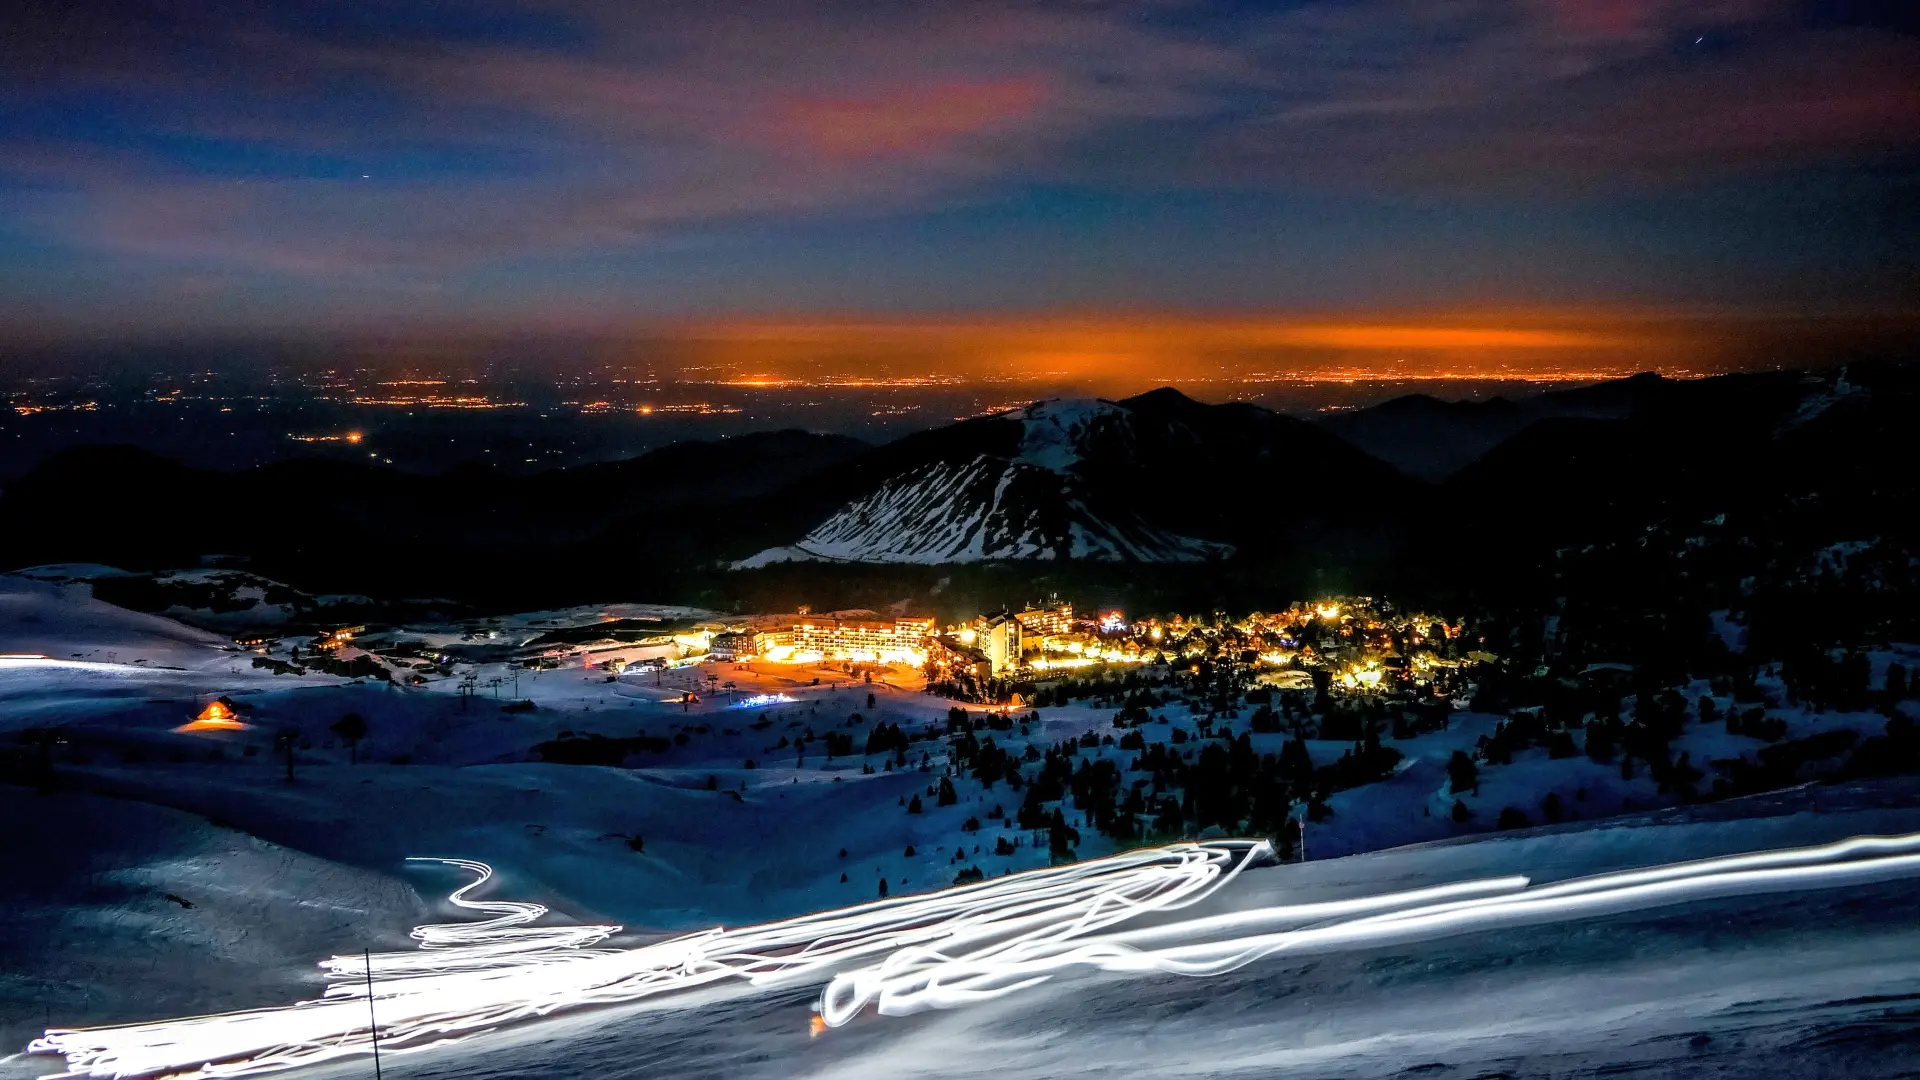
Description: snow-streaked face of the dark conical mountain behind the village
737,400,1233,569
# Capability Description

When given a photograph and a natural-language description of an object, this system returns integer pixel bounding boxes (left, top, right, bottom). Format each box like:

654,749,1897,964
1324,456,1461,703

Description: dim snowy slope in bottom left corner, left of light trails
0,786,426,1045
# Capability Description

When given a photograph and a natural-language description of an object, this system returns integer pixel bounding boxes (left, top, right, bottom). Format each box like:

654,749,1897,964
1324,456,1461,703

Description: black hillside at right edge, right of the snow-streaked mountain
1436,365,1920,573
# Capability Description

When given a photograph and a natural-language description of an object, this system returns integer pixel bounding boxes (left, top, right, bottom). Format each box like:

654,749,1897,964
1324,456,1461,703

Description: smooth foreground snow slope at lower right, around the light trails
18,786,1920,1080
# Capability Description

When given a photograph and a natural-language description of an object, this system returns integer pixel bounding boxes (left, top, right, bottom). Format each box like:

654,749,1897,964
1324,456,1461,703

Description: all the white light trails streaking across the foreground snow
29,834,1920,1078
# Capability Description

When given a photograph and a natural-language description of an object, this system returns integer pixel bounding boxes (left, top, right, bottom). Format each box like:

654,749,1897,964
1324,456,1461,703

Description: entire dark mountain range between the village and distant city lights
0,363,1920,609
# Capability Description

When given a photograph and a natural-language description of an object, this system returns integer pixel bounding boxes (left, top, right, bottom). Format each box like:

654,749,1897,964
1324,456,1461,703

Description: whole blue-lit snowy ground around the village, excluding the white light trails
0,578,1920,1076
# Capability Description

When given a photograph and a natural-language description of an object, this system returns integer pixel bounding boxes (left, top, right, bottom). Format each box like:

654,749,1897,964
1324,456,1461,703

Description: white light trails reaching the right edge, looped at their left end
820,822,1920,1026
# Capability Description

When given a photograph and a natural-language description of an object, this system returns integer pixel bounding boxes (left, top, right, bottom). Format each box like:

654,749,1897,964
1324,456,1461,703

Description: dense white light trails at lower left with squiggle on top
27,840,1271,1078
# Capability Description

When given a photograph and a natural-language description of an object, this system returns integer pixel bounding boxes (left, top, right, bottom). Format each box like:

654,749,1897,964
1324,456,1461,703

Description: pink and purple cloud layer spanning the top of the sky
0,0,1920,297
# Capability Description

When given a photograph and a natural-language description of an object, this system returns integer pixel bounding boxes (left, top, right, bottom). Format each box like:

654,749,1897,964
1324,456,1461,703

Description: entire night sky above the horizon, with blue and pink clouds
0,0,1920,353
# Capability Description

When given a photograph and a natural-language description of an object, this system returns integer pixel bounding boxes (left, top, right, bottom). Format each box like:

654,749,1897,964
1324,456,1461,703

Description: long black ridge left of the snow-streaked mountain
0,430,868,605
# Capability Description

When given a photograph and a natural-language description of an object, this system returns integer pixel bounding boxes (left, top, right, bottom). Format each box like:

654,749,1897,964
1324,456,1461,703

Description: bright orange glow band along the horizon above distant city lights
629,311,1713,390
